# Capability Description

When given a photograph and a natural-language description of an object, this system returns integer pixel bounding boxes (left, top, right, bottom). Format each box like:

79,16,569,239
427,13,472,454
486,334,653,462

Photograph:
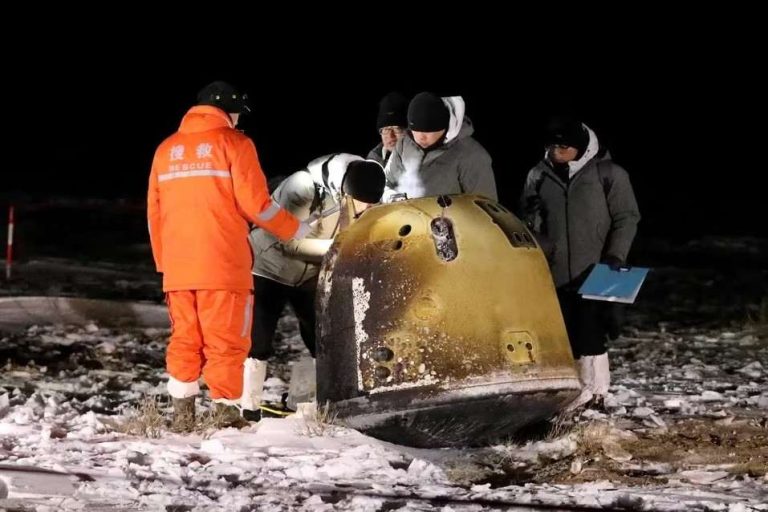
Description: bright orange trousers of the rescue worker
165,290,253,400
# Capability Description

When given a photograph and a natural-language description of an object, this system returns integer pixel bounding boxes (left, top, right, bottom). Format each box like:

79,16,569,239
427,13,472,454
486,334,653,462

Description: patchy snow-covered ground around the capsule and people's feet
0,235,768,512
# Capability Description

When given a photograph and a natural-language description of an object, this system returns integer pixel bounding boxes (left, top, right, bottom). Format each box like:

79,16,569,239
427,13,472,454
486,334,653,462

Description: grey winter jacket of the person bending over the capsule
249,153,362,286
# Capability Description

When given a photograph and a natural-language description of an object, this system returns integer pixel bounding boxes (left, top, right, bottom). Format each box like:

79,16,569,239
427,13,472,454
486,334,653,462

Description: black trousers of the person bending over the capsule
249,276,317,361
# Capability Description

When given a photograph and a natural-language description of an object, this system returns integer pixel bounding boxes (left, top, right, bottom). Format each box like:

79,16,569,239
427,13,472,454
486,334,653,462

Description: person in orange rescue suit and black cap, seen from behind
147,81,310,430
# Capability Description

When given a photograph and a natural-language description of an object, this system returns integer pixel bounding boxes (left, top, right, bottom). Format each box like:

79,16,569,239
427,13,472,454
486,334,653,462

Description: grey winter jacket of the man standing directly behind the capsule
384,96,498,200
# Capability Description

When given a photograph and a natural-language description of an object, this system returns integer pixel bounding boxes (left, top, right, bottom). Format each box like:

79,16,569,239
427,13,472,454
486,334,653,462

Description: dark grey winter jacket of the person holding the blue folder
522,125,640,287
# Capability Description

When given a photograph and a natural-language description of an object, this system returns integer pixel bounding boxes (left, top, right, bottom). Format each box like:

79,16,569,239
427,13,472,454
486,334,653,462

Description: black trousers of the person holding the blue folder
557,285,609,358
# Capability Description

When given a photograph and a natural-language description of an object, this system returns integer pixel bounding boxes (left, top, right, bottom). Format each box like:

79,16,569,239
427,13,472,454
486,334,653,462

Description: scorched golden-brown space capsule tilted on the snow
317,195,580,447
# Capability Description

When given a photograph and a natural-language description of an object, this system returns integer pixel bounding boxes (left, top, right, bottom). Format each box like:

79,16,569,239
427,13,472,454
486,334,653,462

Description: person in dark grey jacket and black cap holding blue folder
521,117,640,409
